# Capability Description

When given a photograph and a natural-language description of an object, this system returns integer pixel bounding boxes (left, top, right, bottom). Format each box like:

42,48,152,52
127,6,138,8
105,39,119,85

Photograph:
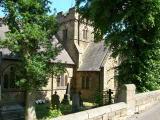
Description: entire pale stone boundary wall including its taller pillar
52,84,160,120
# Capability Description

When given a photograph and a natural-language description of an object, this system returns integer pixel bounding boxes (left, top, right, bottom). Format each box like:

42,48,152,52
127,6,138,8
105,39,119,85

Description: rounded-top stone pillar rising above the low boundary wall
117,84,136,116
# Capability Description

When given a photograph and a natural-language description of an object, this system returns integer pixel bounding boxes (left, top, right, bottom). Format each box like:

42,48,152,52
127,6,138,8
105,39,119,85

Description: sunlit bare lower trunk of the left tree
25,90,37,120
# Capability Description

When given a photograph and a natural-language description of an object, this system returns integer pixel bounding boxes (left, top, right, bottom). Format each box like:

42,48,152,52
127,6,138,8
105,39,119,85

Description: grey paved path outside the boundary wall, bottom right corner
128,104,160,120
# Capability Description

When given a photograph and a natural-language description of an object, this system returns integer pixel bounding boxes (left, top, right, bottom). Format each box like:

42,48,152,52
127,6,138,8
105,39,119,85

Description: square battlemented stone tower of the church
57,8,94,67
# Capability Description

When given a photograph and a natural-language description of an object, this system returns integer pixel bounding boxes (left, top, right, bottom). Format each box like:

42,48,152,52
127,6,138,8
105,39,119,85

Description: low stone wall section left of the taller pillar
53,102,127,120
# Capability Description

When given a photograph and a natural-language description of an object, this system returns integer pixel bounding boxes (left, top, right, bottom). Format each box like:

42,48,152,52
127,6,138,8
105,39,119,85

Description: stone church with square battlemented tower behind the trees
0,8,117,104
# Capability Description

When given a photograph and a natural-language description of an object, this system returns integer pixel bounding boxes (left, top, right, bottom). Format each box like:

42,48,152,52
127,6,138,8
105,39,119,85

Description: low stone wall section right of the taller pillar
135,90,160,113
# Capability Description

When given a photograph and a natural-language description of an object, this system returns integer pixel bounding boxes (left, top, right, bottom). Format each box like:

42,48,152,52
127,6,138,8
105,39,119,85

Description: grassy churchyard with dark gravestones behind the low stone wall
35,89,115,120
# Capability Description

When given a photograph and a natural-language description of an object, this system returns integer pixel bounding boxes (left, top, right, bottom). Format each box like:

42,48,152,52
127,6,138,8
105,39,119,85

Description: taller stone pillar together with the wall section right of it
117,84,160,116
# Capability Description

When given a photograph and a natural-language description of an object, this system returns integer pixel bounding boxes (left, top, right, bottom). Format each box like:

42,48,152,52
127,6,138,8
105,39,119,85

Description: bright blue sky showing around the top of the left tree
0,0,75,16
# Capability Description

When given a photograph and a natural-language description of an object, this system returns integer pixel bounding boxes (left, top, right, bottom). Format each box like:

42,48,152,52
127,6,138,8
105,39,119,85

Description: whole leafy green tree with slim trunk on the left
0,0,63,120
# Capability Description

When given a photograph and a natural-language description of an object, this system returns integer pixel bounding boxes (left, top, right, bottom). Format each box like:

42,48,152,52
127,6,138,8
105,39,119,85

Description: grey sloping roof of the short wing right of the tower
78,41,108,71
